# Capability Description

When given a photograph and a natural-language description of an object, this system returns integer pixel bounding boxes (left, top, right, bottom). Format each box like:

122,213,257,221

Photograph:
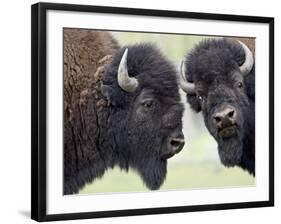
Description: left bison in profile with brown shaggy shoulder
64,29,184,194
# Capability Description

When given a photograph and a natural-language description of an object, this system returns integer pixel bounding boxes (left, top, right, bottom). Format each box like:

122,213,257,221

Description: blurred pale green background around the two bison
79,32,255,194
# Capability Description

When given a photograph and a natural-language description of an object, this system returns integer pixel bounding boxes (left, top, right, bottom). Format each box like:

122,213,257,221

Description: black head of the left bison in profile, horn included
102,44,184,190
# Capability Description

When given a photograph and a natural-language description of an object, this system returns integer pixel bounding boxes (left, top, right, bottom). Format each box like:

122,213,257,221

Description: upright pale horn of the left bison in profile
117,48,138,93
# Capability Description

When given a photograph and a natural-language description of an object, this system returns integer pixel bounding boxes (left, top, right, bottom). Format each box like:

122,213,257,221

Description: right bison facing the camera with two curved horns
180,38,255,175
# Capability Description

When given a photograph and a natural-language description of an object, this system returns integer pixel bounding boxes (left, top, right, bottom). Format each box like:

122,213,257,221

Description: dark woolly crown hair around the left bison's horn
103,44,179,105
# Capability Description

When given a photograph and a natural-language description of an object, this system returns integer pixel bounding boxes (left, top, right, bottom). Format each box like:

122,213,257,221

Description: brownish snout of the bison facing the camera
213,105,237,134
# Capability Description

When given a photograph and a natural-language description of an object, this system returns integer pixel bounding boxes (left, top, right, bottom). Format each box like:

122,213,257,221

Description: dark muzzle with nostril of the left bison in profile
162,132,185,159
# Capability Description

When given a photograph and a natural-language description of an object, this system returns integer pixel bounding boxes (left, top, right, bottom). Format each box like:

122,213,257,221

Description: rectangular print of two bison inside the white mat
63,28,255,194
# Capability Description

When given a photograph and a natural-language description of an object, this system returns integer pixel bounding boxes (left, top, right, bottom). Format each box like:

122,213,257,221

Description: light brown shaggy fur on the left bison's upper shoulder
63,28,119,119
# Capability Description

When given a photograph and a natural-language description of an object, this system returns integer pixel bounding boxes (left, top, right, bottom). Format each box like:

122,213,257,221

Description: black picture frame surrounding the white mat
31,3,274,221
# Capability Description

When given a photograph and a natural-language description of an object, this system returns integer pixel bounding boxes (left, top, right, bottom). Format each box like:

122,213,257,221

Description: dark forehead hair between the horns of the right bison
186,39,245,82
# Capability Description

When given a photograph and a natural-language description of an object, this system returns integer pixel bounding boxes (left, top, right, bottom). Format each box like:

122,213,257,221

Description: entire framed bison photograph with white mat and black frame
31,3,274,221
